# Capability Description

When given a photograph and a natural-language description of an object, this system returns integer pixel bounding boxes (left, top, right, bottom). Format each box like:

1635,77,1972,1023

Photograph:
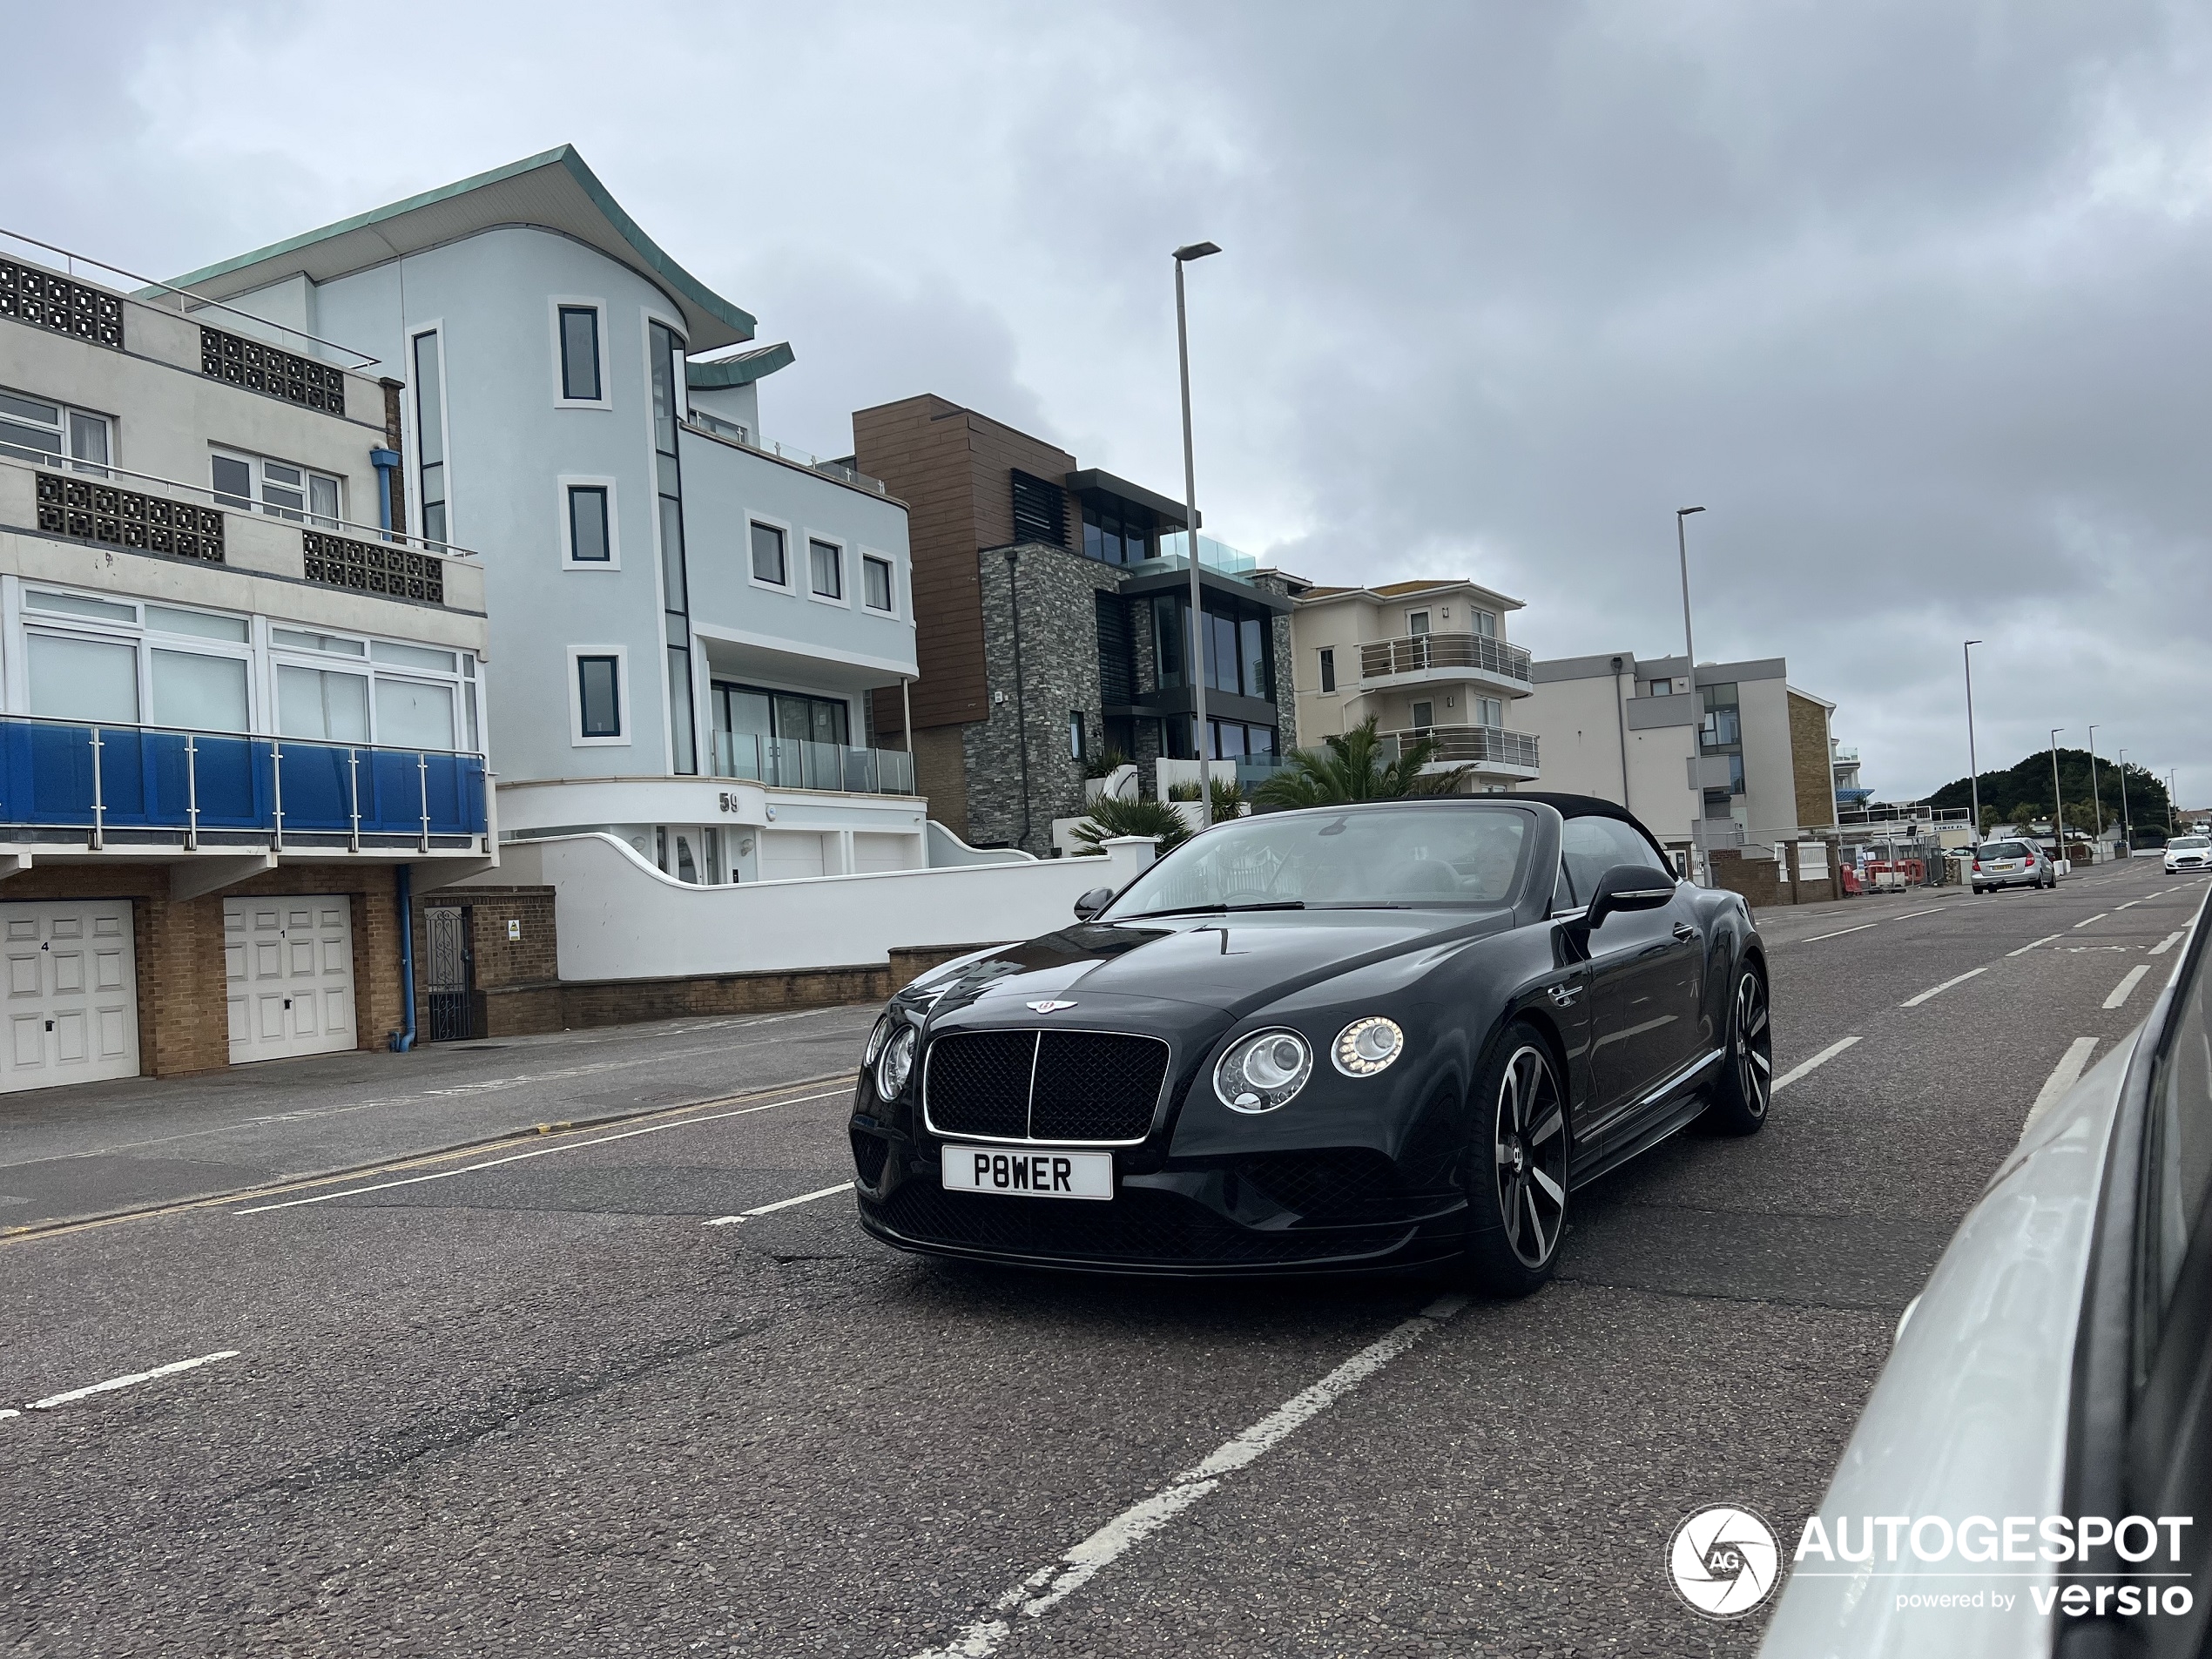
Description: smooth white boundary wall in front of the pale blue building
475,834,1155,980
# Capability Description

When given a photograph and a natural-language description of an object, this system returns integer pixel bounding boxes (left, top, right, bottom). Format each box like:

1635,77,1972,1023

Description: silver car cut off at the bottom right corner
1761,907,2212,1659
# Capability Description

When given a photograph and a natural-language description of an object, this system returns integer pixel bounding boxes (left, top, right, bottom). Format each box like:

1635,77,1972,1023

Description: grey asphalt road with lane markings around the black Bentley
0,867,2201,1659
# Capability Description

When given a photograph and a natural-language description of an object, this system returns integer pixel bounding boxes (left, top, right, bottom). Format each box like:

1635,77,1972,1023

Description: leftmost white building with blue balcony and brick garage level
0,243,496,1090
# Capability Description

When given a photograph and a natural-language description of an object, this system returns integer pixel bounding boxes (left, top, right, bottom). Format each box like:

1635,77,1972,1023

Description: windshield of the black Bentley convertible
1106,803,1531,921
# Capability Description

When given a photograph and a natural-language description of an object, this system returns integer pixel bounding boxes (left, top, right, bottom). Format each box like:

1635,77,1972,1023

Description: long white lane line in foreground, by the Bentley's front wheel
898,1296,1467,1659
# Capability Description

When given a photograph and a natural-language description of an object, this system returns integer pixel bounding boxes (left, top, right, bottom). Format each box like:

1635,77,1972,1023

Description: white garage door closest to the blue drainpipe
224,894,354,1066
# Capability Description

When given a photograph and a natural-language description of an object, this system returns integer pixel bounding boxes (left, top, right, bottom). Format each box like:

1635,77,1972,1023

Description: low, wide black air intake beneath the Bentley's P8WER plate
867,1172,1412,1267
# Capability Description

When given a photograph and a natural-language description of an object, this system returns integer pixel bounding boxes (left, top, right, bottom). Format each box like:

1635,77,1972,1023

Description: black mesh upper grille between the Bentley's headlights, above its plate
922,1031,1168,1142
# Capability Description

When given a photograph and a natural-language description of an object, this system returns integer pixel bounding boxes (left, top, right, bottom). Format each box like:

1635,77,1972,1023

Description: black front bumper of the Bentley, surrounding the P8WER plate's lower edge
852,1119,1467,1277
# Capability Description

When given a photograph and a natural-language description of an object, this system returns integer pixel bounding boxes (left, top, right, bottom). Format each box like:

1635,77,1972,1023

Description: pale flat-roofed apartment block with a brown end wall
1520,651,1836,845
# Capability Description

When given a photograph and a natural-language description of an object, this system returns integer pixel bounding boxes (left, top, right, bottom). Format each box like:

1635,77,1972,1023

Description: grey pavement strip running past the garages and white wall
0,1004,878,1237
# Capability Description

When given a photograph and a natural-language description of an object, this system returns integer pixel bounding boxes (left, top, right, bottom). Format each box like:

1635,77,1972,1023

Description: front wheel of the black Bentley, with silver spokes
1464,1020,1573,1296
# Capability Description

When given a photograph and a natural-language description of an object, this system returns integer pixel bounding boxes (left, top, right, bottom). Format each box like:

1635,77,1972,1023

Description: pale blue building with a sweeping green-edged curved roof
161,146,927,882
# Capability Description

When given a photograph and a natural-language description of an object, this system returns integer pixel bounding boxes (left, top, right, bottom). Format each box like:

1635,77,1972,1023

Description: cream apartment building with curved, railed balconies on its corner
1290,579,1537,790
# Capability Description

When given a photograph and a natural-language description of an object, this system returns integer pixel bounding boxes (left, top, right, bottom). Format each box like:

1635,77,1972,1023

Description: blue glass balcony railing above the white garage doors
0,714,487,852
